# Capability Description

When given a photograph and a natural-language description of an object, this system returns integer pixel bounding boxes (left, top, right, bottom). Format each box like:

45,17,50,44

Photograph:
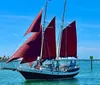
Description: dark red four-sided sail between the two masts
42,17,56,59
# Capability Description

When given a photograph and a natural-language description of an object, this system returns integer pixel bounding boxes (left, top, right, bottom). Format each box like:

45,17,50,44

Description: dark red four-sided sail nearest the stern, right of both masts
60,21,77,58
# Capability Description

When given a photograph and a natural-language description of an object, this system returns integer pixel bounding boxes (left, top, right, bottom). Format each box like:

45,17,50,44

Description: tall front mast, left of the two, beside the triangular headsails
39,0,48,63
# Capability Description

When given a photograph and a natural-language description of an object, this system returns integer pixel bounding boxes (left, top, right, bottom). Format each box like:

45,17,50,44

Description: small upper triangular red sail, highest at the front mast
24,10,42,36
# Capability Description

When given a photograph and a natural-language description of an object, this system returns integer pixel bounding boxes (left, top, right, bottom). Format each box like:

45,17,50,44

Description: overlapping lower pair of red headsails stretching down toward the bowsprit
7,26,42,63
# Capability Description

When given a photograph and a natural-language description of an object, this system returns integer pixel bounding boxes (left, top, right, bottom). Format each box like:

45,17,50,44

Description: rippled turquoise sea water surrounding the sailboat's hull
0,61,100,85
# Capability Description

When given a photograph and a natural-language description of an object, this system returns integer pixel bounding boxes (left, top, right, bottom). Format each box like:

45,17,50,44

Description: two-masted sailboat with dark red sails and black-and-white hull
7,0,79,79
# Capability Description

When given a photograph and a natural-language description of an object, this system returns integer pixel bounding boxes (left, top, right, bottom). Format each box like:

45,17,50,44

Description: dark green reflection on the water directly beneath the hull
24,78,80,85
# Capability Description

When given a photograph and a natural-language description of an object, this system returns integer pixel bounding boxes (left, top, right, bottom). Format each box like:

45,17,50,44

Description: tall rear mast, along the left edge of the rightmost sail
57,0,66,60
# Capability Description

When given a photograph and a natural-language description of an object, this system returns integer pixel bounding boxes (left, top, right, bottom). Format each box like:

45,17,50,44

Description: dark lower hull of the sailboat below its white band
19,71,78,79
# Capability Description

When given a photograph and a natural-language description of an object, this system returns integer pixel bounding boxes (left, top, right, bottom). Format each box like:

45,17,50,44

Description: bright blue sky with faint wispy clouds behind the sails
0,0,100,59
